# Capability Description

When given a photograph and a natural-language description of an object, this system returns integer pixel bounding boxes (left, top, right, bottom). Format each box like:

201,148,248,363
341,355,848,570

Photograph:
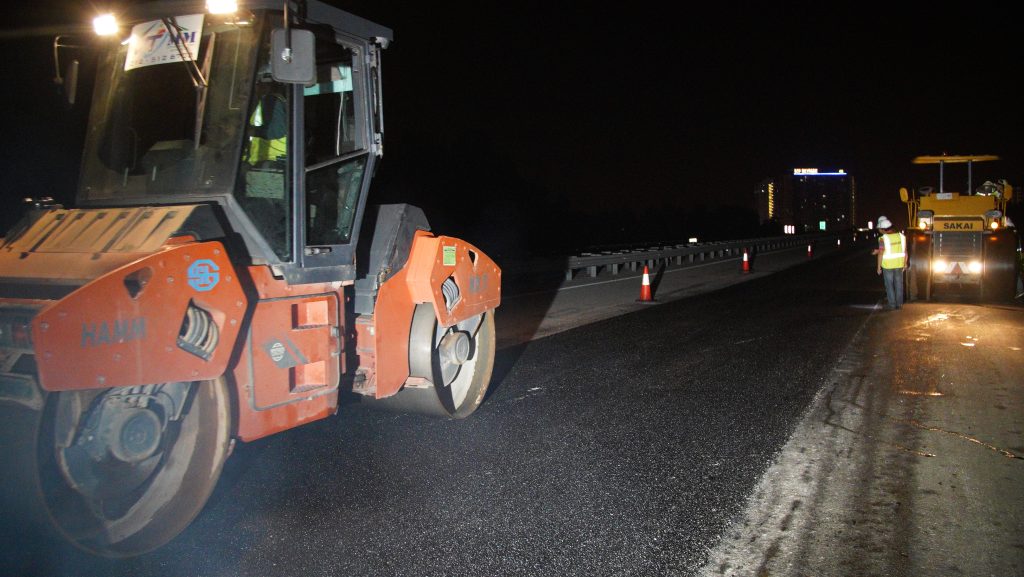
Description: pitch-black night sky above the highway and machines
0,0,1024,255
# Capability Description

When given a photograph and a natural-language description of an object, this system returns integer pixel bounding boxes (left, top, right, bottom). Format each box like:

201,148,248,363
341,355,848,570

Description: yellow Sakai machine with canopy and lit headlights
900,155,1019,301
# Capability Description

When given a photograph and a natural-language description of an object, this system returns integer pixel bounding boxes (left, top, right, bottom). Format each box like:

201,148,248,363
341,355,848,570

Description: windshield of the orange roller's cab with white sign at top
79,14,256,204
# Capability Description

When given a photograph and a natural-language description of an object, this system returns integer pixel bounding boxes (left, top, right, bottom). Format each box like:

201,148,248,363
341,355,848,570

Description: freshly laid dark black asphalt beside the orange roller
5,248,1020,577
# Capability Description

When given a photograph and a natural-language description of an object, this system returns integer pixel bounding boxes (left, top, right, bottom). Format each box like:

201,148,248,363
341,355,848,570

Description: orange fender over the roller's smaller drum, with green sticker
374,231,502,399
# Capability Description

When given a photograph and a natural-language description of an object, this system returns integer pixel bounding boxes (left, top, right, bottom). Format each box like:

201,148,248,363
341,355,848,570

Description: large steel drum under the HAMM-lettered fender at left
37,379,231,558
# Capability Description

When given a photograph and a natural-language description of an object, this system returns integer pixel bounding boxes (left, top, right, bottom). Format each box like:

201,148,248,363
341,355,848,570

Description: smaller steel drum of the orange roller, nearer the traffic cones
362,303,495,419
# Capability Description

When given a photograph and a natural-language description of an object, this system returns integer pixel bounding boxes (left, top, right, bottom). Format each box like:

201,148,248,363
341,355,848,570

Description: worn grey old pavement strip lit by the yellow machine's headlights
701,297,1024,577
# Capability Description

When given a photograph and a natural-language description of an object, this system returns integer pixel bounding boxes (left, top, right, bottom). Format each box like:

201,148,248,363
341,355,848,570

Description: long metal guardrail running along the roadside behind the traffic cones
565,231,858,281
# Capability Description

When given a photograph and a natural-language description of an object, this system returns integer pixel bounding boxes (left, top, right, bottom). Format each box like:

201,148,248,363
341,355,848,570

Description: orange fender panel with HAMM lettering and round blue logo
32,241,246,390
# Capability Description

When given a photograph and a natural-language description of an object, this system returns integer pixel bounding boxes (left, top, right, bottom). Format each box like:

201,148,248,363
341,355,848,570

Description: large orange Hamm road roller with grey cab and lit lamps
0,0,501,557
